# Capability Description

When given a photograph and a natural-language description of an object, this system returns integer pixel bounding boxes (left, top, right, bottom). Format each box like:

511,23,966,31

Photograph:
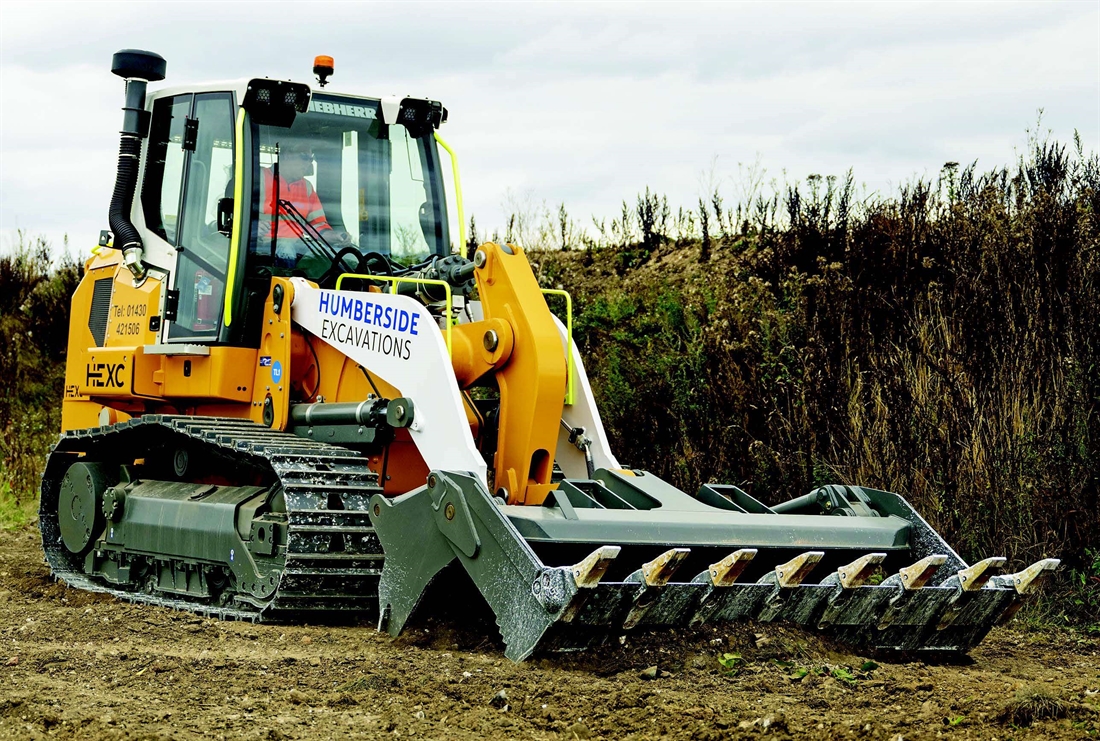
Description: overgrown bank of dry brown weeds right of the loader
536,131,1100,622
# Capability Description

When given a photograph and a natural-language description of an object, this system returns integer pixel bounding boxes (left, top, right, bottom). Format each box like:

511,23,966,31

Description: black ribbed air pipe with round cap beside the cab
110,48,168,280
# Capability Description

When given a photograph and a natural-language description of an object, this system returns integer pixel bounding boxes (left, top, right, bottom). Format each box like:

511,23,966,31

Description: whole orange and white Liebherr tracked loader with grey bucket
40,49,1057,661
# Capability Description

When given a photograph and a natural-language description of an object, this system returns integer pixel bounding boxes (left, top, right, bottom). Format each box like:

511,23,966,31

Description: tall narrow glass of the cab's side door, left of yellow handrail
168,92,233,340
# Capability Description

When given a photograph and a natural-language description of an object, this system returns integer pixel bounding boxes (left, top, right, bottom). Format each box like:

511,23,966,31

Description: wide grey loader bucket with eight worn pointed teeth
371,469,1057,662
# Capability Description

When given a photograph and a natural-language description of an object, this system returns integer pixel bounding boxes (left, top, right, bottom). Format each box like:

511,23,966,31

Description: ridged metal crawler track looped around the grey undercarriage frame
40,414,384,621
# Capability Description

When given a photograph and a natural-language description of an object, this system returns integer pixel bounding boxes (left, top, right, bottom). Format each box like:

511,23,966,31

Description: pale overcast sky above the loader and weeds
0,0,1100,252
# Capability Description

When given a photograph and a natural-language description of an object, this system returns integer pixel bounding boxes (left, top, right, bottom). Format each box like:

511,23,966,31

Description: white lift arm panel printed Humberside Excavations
292,278,487,485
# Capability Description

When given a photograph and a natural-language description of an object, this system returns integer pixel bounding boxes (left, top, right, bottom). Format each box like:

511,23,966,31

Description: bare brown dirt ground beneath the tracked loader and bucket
0,530,1100,741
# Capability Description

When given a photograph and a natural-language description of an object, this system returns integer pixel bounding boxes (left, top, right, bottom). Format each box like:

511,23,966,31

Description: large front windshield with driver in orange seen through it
250,95,450,278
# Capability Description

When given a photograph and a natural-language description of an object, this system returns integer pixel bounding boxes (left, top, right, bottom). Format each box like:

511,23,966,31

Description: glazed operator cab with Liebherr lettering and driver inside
141,73,451,345
